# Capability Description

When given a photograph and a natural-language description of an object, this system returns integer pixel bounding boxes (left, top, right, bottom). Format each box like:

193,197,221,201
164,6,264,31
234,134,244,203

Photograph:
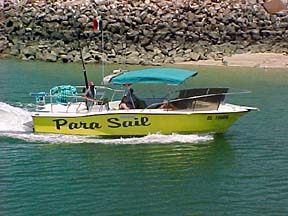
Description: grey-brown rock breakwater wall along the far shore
0,0,288,64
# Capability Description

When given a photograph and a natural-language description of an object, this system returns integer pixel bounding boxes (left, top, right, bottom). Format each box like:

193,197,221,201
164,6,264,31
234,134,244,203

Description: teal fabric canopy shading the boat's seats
110,68,197,85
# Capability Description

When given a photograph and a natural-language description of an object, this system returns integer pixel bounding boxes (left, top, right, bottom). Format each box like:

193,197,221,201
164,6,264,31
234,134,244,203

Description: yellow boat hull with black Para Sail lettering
32,110,249,136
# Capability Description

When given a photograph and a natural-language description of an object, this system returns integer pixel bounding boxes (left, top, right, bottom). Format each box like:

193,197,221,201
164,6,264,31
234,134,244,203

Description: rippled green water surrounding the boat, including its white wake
0,60,288,216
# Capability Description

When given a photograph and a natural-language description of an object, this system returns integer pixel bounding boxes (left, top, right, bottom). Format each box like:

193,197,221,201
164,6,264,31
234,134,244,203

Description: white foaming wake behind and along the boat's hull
0,102,214,144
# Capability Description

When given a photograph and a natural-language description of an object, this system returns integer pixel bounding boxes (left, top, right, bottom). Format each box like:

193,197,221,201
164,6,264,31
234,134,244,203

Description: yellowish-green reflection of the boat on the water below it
31,135,233,179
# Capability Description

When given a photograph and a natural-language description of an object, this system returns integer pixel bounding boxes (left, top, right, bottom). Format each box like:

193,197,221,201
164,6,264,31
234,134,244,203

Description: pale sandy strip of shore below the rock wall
181,53,288,68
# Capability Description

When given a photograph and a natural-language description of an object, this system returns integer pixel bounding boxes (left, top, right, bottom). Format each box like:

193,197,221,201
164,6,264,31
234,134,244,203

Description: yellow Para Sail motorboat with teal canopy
31,68,256,136
